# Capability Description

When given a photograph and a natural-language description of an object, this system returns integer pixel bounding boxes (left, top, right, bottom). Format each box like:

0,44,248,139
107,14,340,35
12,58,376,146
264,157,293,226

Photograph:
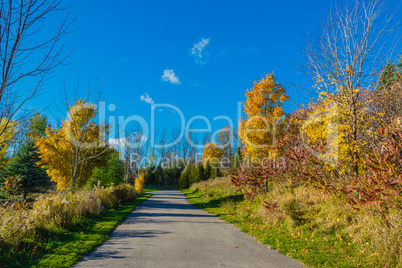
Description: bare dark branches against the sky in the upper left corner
0,0,70,140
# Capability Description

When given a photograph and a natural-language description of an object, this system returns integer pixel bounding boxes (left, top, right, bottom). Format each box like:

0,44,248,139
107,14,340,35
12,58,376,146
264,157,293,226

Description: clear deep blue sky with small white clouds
24,0,396,135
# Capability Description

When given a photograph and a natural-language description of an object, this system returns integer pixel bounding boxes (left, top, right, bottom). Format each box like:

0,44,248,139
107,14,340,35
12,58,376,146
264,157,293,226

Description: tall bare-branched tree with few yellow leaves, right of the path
299,0,400,176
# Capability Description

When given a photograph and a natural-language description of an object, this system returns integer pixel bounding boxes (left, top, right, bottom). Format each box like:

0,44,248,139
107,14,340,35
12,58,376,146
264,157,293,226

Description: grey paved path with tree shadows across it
76,191,304,268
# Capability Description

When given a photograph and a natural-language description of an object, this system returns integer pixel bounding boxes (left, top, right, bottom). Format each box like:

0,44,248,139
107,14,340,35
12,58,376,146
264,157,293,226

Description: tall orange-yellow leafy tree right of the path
239,74,289,159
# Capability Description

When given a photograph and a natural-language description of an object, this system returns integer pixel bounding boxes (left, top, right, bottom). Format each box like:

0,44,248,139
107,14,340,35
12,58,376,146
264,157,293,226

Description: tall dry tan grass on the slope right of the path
191,177,402,267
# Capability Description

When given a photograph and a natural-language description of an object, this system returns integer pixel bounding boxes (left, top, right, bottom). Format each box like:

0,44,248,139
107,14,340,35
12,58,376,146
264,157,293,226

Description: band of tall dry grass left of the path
0,185,137,250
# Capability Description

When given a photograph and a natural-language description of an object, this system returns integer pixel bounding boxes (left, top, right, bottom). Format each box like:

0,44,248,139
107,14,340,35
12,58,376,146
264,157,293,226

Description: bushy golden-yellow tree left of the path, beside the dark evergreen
37,100,112,191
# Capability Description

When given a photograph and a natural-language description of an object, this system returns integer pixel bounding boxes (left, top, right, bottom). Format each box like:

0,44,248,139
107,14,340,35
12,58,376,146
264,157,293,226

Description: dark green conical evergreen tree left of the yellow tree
3,140,50,199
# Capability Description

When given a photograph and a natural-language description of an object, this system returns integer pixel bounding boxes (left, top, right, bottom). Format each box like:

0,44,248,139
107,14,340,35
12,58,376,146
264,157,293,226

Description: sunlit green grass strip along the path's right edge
182,190,379,267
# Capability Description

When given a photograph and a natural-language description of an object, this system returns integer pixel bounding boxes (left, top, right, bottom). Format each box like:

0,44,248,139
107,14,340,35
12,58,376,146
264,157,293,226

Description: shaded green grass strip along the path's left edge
0,193,151,267
